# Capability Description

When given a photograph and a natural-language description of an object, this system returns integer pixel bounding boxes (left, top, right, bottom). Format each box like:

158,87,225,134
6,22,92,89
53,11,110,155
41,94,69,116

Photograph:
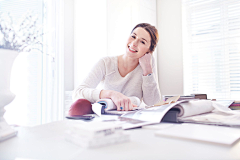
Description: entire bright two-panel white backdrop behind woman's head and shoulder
74,0,156,87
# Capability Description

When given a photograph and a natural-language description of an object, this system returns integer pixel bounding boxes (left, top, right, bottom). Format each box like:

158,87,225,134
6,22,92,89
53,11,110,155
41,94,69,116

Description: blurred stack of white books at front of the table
65,121,130,148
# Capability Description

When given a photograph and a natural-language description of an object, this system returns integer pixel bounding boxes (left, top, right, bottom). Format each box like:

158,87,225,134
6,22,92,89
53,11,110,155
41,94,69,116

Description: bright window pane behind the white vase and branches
0,0,43,126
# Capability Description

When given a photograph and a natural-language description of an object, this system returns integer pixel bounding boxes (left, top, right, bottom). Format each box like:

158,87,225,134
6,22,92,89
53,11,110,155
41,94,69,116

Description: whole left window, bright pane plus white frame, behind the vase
0,0,64,126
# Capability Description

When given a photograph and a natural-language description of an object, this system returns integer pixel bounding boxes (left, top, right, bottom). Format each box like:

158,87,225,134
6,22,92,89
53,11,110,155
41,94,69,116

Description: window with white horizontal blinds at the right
182,0,240,99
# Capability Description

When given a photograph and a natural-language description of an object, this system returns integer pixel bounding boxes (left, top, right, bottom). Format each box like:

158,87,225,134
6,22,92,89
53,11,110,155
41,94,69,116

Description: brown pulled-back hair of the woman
131,23,159,52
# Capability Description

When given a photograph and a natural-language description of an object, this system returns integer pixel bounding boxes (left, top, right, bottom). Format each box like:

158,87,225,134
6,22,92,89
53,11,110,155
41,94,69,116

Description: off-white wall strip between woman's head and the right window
157,0,183,95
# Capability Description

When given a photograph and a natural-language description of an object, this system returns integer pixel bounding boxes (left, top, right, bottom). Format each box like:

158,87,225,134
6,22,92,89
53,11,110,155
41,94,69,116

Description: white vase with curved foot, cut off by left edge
0,49,18,141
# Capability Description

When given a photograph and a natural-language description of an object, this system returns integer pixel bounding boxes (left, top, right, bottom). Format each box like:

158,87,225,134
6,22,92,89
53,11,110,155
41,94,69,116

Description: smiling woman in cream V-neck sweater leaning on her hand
73,23,161,114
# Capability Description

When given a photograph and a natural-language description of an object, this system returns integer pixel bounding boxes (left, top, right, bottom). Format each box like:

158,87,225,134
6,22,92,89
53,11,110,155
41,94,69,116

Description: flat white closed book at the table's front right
155,123,240,145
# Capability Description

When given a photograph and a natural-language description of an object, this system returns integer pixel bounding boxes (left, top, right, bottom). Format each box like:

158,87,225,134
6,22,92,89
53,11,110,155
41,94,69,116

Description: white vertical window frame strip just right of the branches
42,0,64,123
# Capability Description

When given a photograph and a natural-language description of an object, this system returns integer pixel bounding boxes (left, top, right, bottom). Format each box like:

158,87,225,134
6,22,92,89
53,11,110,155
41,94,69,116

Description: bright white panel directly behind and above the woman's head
107,0,157,55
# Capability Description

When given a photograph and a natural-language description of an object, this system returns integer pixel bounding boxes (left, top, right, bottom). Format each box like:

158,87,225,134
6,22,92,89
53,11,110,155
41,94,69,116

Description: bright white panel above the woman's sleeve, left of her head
74,0,107,88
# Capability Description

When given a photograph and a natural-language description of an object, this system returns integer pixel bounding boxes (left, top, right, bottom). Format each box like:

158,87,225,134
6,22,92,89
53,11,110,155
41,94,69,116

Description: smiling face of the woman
126,27,151,58
